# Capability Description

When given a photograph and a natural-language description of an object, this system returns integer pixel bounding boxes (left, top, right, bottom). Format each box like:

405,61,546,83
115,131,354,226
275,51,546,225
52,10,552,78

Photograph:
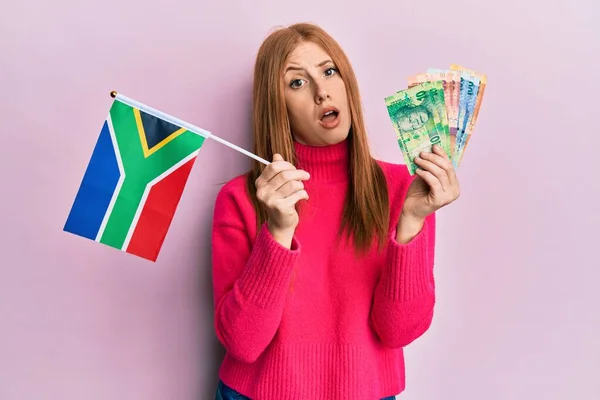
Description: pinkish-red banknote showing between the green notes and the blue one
408,70,460,159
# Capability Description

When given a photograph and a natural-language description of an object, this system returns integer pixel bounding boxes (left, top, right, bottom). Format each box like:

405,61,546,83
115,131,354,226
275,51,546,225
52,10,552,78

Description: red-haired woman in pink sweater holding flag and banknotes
212,24,458,400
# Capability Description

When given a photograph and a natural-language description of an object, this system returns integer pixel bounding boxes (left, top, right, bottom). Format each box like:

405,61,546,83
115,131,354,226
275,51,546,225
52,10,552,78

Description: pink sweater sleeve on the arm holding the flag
212,186,300,363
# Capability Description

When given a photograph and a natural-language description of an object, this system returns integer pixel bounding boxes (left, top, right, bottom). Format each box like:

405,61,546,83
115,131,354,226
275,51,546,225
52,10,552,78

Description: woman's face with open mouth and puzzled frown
283,42,351,146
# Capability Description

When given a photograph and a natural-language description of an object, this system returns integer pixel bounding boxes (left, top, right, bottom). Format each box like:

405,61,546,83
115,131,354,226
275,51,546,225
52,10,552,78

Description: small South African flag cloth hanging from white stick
64,99,205,261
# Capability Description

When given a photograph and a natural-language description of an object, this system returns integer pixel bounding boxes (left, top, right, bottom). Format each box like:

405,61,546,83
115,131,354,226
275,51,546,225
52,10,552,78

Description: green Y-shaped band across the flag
100,101,204,248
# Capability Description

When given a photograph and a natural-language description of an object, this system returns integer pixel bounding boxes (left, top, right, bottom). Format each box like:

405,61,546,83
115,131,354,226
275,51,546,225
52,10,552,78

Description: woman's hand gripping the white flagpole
255,154,310,248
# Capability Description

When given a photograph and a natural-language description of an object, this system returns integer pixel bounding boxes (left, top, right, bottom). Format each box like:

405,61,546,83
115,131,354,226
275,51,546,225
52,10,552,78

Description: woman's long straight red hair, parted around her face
246,23,389,251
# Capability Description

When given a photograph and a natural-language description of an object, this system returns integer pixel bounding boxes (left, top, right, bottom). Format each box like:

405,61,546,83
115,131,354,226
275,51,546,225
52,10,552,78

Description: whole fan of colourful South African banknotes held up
385,64,487,175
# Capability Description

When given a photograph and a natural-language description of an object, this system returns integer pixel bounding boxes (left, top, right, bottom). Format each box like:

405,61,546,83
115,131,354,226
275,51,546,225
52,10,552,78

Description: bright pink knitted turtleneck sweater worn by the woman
212,138,435,400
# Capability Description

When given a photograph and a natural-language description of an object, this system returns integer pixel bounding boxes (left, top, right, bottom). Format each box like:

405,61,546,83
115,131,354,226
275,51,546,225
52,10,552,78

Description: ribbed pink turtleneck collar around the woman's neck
294,139,350,182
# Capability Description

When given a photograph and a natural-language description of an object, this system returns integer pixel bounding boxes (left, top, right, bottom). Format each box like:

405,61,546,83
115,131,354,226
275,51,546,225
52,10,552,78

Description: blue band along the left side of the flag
64,121,120,240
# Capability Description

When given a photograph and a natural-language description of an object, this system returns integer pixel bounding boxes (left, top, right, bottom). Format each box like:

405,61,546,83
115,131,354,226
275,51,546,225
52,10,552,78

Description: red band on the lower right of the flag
127,157,196,261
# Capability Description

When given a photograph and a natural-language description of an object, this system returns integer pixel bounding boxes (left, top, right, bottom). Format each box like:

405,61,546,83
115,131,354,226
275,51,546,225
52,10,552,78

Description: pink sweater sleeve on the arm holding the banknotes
371,214,436,348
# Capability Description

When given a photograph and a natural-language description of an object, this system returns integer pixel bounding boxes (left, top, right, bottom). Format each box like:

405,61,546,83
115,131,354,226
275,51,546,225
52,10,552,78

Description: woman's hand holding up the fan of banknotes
397,145,460,242
